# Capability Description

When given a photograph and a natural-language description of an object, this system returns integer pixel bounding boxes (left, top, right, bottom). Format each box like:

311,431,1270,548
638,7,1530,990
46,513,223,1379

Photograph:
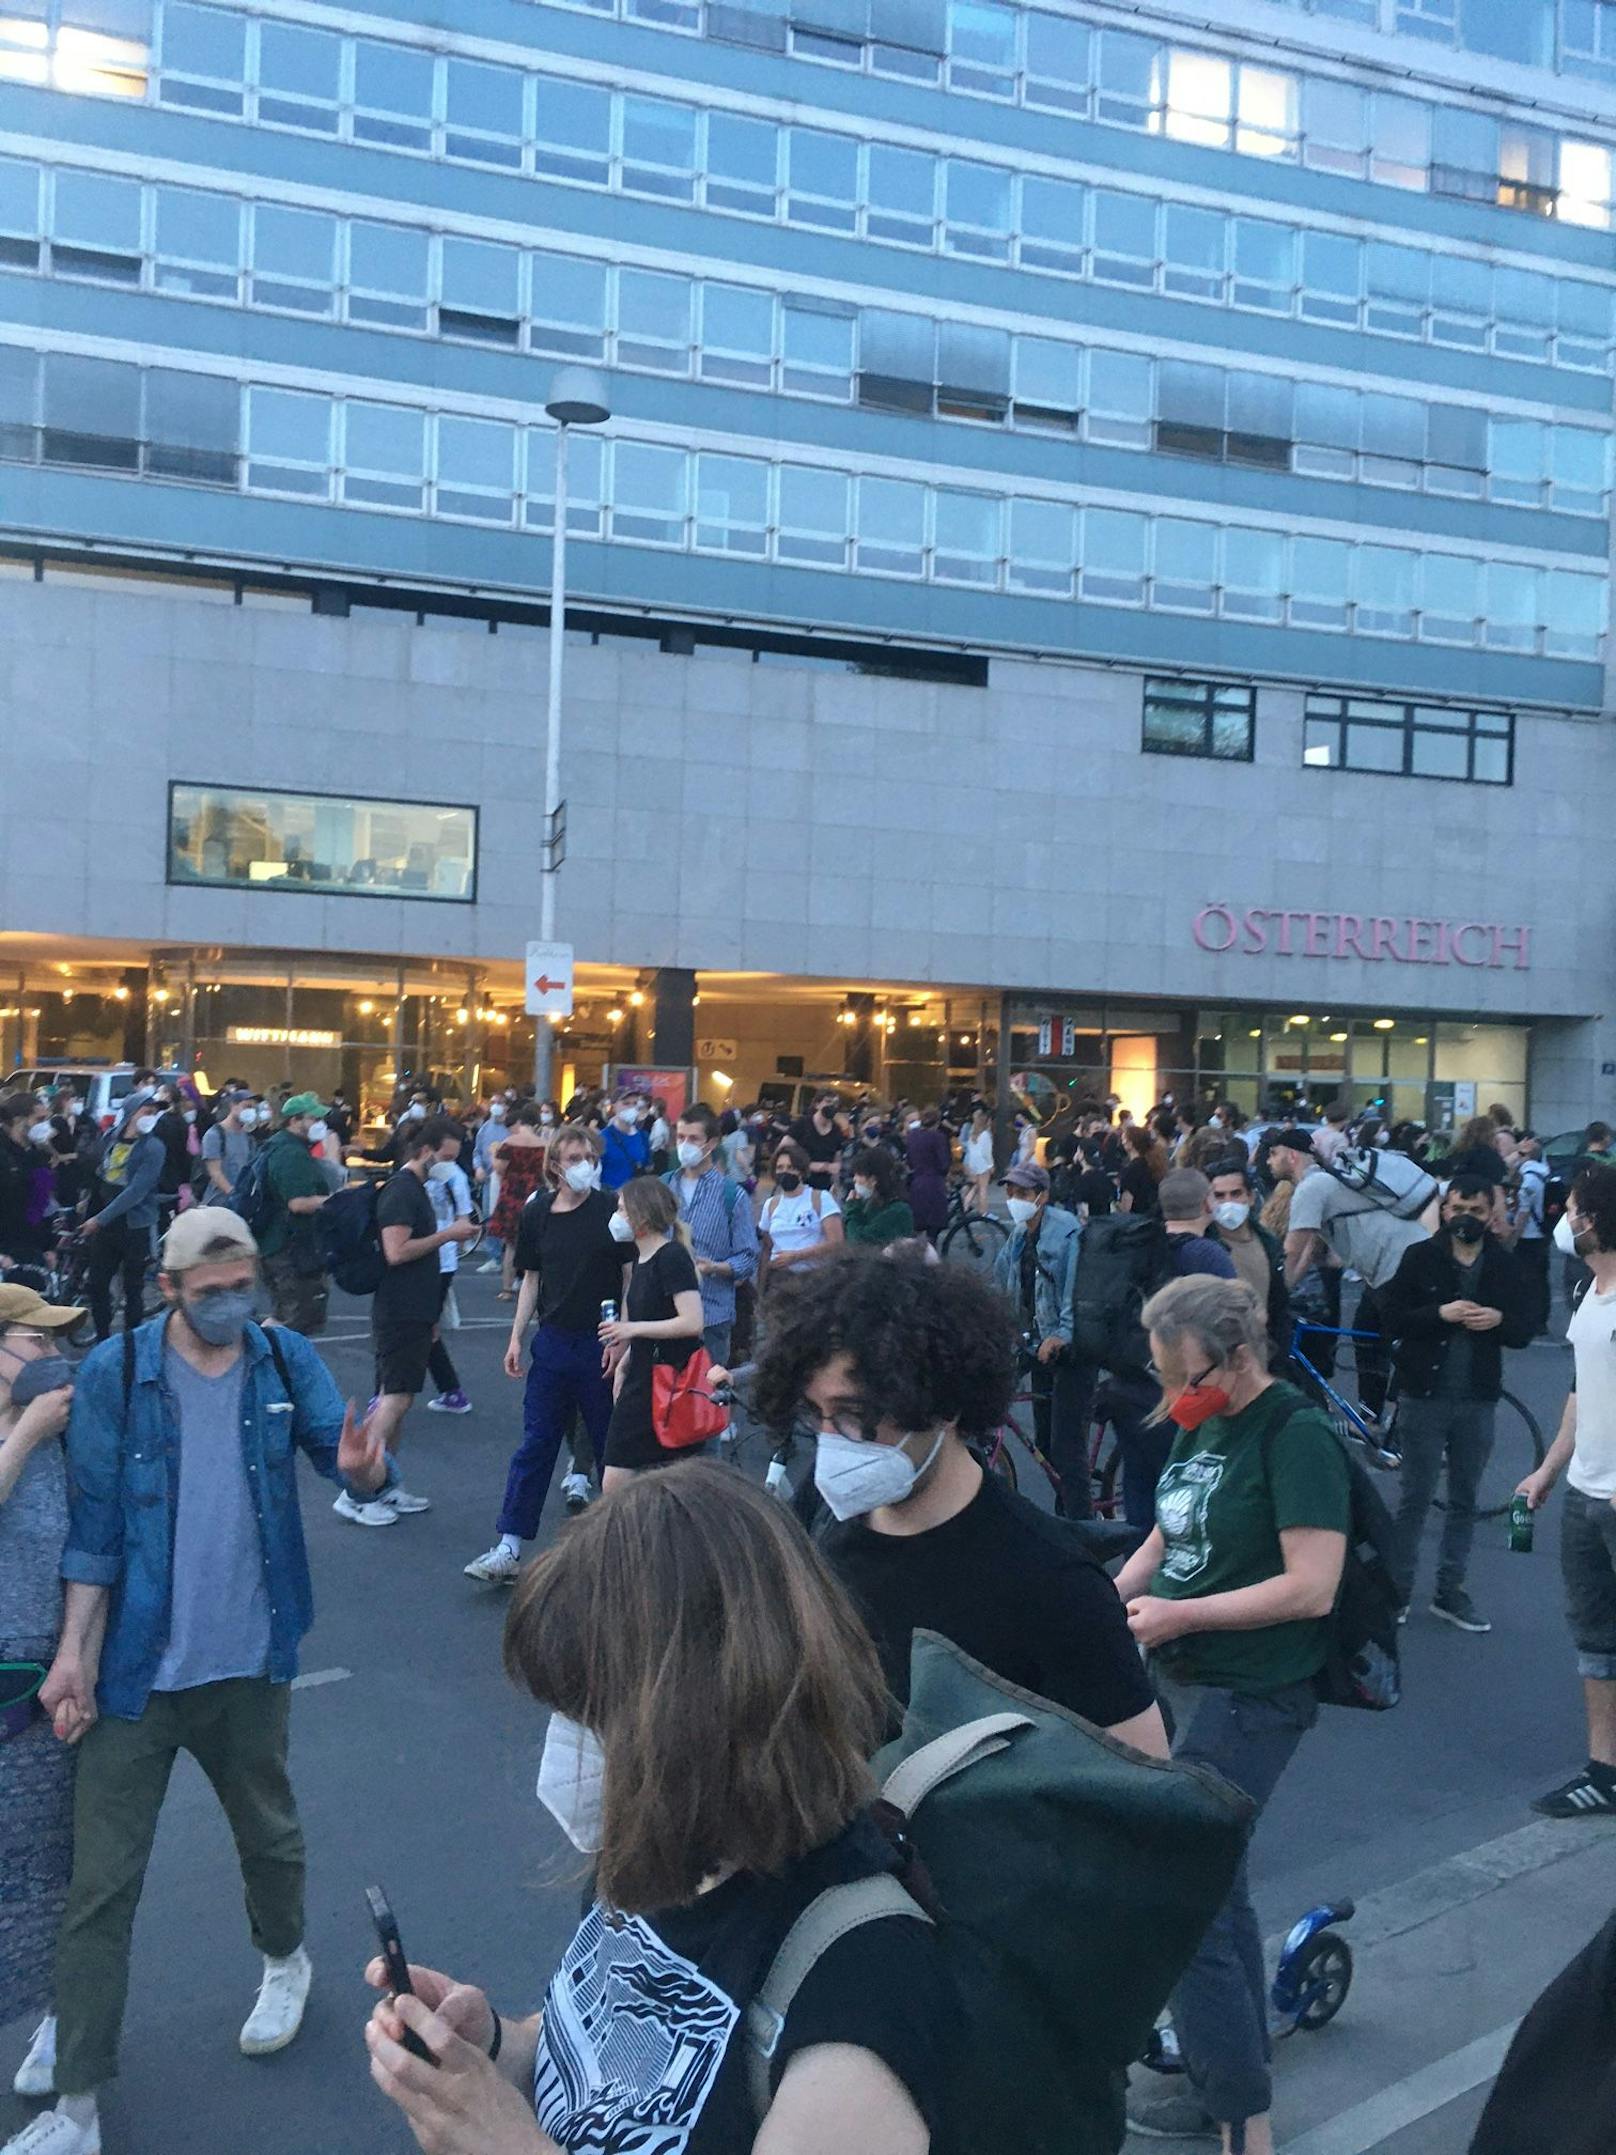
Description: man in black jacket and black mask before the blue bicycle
1381,1174,1536,1631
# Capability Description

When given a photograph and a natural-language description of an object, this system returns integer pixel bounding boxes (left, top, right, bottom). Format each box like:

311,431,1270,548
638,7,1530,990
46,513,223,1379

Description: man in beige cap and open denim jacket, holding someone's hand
6,1207,390,2155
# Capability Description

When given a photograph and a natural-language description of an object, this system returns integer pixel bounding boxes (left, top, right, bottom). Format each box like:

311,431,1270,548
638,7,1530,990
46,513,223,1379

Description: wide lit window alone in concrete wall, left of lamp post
168,784,476,905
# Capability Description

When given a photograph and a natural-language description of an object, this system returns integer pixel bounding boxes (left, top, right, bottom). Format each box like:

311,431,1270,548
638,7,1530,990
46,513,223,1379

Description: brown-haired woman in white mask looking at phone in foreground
366,1461,963,2155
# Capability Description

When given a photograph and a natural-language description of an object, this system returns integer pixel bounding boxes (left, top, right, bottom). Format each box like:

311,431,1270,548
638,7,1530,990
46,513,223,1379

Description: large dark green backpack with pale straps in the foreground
746,1631,1254,2155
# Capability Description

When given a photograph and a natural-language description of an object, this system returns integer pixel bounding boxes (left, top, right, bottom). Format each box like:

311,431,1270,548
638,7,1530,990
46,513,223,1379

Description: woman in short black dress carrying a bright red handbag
601,1174,702,1489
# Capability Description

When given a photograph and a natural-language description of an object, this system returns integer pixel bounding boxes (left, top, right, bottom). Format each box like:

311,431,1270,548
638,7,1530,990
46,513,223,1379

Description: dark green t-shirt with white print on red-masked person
1151,1384,1351,1692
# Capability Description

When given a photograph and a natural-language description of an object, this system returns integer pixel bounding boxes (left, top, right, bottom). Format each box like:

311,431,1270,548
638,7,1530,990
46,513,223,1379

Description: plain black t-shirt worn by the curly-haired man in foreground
814,1474,1153,1728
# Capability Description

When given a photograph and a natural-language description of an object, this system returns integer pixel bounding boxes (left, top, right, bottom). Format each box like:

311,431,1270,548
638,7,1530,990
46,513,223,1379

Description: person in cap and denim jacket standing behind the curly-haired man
993,1164,1095,1519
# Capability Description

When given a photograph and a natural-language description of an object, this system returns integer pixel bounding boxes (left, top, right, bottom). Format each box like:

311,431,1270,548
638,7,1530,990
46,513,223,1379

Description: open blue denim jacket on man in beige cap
62,1312,353,1722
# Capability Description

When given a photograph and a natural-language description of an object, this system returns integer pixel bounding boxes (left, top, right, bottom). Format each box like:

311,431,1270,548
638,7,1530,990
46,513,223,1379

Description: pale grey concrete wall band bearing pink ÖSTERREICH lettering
0,582,1616,1094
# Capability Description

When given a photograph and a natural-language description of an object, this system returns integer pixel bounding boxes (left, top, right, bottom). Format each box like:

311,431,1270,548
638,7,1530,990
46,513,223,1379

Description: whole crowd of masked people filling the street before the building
0,1073,1616,2155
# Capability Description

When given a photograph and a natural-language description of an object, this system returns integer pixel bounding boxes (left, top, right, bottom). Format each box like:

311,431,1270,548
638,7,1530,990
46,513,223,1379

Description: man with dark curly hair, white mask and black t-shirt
752,1250,1168,1756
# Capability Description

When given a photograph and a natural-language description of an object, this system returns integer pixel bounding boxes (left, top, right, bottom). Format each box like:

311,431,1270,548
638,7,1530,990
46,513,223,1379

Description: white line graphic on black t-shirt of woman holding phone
532,1907,739,2155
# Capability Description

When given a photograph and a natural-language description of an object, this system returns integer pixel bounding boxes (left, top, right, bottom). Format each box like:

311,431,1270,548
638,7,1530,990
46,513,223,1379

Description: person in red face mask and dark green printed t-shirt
1116,1278,1351,2155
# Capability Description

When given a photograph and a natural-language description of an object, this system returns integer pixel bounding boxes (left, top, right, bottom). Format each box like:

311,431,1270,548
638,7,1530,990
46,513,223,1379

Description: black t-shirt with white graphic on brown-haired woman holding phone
534,1819,965,2155
